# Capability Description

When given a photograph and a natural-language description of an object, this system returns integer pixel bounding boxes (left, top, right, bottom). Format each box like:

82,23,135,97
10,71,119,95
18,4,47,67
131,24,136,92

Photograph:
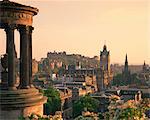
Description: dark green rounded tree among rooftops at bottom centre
73,95,99,117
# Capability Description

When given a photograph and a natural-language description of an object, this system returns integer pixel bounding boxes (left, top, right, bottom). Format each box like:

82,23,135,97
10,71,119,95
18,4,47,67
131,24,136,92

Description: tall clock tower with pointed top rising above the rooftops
97,45,113,91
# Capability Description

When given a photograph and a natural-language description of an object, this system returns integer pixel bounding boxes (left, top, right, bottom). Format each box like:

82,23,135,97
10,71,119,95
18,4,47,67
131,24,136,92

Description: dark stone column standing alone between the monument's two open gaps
5,25,16,90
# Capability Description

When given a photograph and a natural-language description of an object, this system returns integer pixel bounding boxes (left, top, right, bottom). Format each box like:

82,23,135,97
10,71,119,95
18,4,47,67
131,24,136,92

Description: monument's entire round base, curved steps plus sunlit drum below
0,88,47,120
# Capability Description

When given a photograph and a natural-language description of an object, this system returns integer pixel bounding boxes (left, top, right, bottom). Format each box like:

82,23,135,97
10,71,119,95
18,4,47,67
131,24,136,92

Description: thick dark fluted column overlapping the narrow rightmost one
18,25,30,89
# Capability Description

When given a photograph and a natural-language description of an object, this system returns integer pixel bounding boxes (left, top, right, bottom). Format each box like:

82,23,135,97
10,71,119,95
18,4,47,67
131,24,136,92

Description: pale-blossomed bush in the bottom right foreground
104,99,150,120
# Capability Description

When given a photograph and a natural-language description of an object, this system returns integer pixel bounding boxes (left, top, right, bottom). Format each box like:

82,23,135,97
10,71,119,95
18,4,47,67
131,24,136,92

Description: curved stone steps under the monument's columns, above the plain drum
0,88,47,109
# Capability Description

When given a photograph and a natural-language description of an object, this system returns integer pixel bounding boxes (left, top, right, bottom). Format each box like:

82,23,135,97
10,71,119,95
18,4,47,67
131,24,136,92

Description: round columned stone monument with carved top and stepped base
0,0,47,120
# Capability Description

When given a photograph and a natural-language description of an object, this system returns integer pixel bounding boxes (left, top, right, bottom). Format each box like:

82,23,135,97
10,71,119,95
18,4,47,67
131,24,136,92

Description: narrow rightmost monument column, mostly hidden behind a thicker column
29,26,34,87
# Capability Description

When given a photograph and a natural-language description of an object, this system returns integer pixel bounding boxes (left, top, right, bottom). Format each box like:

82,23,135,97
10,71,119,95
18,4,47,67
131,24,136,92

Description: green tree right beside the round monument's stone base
42,87,61,115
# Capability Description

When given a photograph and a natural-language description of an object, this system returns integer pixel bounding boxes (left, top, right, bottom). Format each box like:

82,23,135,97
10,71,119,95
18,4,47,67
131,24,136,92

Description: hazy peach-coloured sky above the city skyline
0,0,150,64
